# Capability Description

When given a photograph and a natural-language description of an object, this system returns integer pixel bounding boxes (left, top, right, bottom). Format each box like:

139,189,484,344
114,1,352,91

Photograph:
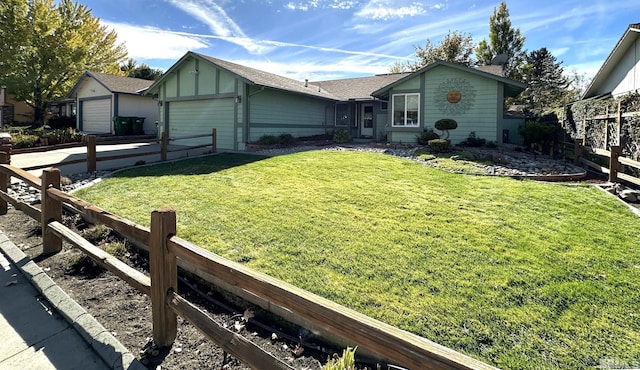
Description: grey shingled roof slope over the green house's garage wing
191,52,337,100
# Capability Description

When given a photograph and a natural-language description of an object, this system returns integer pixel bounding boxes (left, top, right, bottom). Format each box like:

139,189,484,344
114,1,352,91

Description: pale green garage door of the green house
169,98,234,149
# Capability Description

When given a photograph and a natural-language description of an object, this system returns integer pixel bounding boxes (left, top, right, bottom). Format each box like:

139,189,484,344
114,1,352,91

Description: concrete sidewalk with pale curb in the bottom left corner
0,232,146,370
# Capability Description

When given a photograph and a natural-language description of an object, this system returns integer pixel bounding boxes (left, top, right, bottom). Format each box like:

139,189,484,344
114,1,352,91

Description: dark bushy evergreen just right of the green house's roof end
521,48,574,113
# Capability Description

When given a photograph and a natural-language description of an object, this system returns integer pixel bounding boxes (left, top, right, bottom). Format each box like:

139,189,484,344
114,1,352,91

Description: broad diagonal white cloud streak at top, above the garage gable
168,0,265,54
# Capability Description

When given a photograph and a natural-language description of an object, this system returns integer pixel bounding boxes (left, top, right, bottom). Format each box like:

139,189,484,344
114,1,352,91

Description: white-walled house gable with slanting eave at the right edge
582,23,640,99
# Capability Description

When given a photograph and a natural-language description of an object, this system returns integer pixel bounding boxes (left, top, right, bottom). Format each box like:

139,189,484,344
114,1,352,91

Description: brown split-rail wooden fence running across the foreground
0,162,495,369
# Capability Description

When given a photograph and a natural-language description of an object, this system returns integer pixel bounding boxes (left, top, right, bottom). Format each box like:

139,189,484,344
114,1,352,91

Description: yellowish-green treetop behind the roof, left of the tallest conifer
391,31,473,72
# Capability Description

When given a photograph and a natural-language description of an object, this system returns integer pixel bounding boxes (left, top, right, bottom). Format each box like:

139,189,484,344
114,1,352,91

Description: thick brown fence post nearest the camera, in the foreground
149,208,178,347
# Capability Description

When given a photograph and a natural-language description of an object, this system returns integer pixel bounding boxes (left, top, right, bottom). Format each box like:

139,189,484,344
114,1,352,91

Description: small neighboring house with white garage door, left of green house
68,71,158,135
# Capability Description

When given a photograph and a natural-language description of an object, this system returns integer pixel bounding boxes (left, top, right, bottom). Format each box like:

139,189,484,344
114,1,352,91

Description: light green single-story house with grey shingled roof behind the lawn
146,52,525,150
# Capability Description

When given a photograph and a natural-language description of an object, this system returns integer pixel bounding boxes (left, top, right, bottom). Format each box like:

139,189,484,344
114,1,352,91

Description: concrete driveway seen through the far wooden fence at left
11,143,211,177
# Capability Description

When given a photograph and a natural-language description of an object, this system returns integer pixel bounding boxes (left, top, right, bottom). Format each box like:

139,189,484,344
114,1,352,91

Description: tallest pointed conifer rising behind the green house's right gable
475,2,525,80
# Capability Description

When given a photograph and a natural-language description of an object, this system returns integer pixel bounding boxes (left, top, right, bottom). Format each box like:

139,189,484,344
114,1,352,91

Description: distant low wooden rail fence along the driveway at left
14,128,217,172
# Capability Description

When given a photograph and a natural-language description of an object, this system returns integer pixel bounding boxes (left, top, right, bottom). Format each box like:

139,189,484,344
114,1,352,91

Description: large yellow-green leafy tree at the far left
0,0,127,123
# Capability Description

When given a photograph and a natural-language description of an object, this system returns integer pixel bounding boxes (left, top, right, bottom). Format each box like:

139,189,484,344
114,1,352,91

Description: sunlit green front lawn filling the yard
78,151,640,369
